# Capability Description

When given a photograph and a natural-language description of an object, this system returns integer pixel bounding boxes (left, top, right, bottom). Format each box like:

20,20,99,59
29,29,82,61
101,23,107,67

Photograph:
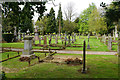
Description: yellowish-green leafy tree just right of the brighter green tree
88,7,107,34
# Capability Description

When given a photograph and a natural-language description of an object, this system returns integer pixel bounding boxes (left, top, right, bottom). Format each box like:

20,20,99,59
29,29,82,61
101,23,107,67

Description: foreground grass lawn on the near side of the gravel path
0,53,118,78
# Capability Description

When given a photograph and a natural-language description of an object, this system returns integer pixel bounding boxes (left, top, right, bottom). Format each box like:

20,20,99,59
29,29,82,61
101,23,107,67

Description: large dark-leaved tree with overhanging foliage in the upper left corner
2,2,46,32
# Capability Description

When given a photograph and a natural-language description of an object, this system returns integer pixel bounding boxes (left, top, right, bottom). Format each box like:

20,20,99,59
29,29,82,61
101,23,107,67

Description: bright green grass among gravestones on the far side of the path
2,36,118,51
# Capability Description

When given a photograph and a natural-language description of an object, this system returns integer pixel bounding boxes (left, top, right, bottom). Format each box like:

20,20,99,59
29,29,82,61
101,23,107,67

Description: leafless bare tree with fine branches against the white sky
64,2,76,21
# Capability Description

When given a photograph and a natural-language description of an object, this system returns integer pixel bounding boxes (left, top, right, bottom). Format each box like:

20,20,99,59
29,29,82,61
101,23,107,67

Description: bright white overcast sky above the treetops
33,0,112,21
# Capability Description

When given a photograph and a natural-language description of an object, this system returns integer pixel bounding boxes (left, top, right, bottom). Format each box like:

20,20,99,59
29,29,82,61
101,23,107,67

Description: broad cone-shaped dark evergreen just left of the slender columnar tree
47,7,57,33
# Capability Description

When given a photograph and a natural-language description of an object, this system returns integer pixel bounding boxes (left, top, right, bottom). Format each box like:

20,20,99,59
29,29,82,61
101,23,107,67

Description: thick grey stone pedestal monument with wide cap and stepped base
21,36,34,57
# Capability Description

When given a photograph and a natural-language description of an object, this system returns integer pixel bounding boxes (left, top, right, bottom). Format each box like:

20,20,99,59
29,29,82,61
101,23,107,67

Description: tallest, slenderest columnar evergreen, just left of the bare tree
56,4,63,34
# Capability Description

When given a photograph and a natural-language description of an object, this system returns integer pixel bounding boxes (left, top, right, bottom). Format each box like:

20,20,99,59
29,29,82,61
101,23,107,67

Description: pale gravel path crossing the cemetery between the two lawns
2,48,117,55
